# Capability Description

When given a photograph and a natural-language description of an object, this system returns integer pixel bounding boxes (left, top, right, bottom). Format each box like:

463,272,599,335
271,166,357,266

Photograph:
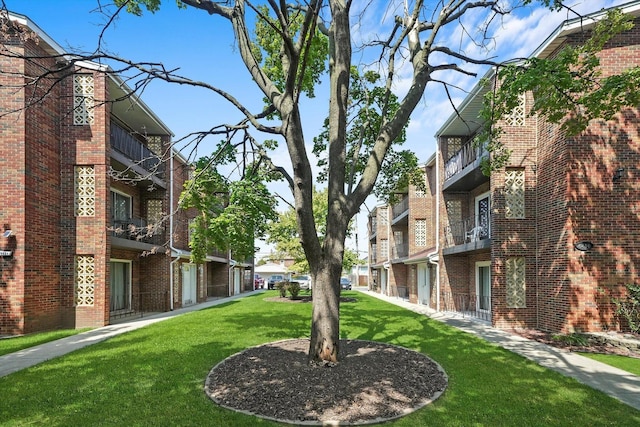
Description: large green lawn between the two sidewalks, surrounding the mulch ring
0,291,640,427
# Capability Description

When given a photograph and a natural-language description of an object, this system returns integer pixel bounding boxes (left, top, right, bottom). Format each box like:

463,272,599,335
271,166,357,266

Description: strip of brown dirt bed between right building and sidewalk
510,329,640,359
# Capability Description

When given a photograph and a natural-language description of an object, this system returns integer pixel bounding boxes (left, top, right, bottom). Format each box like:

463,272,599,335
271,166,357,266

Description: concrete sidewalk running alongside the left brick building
0,290,262,378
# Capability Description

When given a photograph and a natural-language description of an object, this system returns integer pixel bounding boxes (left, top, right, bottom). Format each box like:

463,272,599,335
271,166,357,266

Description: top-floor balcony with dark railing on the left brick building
111,122,165,185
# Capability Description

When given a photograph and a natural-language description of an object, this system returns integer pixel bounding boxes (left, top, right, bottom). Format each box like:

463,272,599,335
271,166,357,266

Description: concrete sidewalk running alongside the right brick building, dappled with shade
358,289,640,410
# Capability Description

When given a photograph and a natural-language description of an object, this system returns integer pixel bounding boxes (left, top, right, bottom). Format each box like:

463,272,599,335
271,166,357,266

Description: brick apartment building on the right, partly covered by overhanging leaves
370,1,640,333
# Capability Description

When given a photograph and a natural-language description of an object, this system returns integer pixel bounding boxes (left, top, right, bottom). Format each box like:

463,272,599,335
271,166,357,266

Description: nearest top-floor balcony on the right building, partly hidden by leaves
443,139,489,191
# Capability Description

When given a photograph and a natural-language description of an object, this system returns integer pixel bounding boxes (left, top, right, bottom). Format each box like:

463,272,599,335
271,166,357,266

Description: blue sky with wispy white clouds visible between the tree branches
5,0,626,258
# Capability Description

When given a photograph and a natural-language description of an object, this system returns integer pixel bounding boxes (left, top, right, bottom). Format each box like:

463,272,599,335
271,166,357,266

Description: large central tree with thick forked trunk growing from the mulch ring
111,0,637,363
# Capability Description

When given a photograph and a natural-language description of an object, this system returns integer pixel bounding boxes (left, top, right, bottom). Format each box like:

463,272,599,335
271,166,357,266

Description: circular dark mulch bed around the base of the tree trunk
204,339,448,425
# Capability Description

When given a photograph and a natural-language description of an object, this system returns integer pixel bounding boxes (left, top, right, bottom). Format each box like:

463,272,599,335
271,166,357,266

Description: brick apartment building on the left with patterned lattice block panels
0,14,252,335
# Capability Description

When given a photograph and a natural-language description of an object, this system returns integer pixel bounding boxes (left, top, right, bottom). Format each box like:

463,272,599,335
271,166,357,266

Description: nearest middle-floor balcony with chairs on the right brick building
444,215,491,252
